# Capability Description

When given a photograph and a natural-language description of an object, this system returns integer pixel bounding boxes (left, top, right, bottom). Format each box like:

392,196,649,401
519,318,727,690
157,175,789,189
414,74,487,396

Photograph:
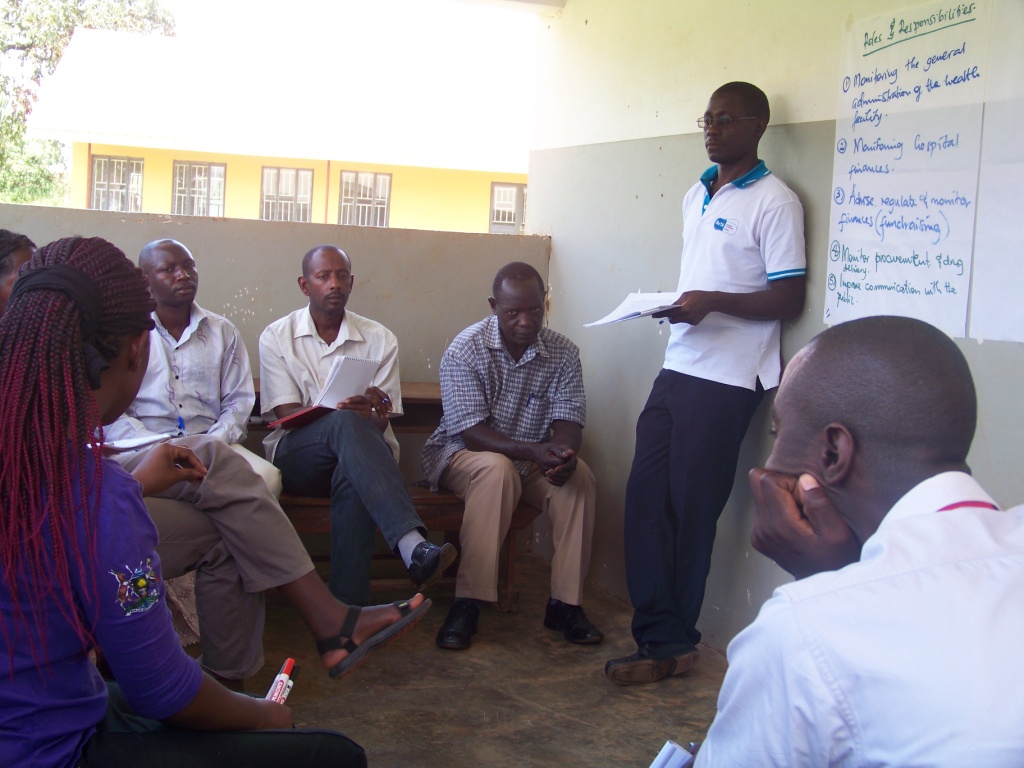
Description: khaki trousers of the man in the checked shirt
441,450,597,605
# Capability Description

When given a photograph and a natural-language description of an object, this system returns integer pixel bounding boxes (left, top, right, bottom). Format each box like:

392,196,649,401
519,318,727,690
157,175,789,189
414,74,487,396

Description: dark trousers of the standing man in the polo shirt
625,369,764,653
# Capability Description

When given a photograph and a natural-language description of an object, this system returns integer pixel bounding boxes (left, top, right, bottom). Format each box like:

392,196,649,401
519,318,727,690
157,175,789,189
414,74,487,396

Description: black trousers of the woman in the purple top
76,683,367,768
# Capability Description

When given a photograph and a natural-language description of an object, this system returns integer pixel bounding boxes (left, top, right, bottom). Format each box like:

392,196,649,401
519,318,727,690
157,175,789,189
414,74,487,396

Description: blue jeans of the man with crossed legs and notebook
273,411,426,605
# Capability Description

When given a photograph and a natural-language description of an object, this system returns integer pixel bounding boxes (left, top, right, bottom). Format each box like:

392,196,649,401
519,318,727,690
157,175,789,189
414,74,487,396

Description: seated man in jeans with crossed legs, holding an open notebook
259,245,457,605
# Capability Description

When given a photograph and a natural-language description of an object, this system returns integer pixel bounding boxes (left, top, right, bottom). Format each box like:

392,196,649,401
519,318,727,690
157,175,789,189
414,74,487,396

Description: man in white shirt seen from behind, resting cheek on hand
696,317,1024,768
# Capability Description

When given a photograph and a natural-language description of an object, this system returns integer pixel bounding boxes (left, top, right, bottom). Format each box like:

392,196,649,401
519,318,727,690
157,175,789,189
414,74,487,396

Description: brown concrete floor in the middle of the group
246,554,725,768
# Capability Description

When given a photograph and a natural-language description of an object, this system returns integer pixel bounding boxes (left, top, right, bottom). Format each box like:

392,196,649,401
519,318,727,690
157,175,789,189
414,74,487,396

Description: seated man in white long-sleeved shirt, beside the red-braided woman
106,240,281,496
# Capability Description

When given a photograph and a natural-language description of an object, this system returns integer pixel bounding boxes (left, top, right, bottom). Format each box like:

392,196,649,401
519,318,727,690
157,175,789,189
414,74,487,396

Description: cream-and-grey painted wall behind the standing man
526,0,1024,648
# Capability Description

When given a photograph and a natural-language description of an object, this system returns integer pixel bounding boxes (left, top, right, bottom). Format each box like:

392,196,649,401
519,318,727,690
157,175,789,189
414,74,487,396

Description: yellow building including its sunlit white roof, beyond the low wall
30,30,528,233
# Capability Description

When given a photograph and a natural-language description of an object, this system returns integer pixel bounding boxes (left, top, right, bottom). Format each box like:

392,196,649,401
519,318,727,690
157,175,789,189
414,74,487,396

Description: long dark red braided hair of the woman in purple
0,238,156,669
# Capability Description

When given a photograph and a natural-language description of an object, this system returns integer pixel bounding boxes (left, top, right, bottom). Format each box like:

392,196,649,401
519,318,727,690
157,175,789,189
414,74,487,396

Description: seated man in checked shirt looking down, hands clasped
423,262,604,650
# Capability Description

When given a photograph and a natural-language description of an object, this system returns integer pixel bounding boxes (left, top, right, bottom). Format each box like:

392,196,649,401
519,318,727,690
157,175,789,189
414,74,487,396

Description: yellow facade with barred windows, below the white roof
70,141,526,232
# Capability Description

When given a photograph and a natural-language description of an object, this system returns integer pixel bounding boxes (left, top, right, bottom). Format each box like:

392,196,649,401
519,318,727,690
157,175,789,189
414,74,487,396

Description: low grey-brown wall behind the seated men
0,205,550,381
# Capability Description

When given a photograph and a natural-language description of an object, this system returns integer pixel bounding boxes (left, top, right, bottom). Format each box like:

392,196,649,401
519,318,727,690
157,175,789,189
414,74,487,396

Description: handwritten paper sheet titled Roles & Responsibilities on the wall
824,2,989,336
